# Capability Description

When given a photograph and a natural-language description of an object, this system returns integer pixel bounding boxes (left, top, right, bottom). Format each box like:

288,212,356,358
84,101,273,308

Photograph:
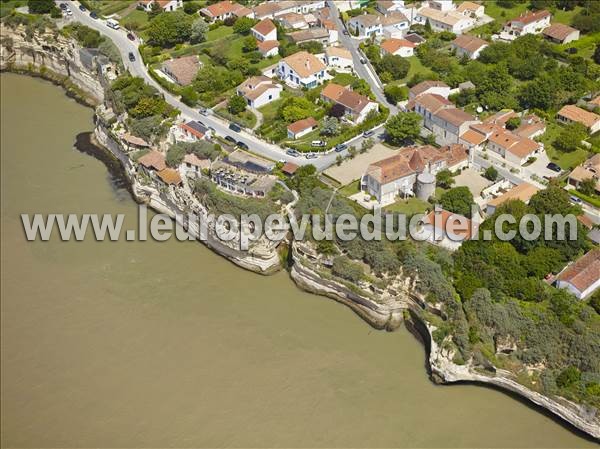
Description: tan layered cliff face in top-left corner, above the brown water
0,25,104,104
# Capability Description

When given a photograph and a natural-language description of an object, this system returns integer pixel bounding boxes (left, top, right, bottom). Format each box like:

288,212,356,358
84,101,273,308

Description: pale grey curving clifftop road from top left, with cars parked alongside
61,1,346,171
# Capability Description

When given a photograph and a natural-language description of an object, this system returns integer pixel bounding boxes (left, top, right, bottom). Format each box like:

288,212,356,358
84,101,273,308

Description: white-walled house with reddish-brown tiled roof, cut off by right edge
556,248,600,299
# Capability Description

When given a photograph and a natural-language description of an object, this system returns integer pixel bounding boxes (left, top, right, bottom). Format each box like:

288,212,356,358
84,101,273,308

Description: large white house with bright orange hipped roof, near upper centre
277,51,327,88
